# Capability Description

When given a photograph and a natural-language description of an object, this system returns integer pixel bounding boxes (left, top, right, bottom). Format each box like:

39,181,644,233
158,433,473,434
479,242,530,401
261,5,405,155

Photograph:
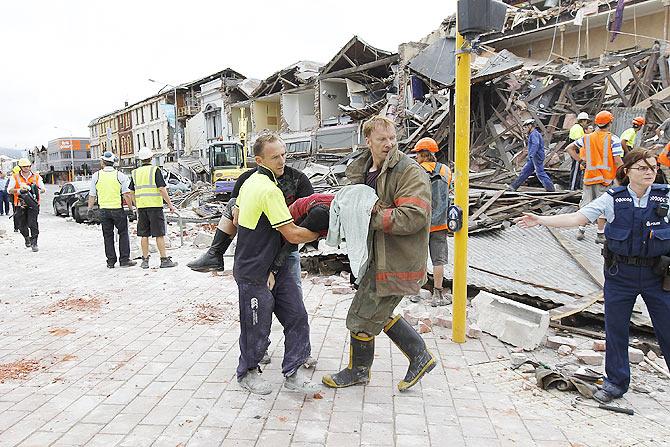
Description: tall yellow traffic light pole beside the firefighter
451,33,470,343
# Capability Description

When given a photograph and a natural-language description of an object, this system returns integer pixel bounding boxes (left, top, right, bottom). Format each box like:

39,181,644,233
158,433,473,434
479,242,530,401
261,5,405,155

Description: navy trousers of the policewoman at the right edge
603,264,670,397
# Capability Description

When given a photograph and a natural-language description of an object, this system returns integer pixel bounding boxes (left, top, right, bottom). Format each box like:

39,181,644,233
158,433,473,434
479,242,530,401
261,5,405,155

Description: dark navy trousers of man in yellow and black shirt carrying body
237,262,311,379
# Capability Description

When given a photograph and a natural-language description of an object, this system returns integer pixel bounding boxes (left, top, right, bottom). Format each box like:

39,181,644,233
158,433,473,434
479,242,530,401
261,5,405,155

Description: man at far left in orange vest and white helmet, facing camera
7,158,46,251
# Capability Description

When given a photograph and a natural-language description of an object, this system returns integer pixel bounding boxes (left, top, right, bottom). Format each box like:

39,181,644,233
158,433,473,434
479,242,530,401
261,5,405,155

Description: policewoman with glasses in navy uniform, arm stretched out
516,149,670,402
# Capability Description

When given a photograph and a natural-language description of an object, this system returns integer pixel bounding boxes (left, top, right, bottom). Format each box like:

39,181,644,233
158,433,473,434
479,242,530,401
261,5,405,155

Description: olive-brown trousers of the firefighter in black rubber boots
347,259,402,335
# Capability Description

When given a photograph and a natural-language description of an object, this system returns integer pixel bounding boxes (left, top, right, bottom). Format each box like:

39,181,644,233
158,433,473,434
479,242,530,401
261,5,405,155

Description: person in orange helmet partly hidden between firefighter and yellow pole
410,137,451,307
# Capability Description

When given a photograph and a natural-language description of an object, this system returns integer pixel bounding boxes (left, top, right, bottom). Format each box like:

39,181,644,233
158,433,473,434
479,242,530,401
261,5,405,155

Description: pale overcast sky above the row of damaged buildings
0,0,456,149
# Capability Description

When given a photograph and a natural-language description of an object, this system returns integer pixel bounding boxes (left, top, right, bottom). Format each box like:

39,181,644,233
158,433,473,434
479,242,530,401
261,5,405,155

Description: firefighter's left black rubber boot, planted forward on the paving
321,333,375,388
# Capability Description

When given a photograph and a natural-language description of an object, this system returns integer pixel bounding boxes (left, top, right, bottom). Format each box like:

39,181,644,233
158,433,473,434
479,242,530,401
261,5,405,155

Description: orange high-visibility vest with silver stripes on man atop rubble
579,130,616,186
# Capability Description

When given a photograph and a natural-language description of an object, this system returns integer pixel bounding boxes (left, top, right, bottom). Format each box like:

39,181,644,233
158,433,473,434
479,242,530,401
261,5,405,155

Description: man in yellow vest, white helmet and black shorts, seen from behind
130,146,177,269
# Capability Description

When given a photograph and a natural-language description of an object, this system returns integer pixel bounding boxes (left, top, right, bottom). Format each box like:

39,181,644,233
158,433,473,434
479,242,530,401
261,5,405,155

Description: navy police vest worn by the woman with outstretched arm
605,184,670,258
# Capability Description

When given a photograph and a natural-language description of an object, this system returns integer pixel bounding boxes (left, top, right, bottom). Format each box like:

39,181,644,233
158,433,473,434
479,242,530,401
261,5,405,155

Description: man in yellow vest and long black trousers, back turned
88,151,137,269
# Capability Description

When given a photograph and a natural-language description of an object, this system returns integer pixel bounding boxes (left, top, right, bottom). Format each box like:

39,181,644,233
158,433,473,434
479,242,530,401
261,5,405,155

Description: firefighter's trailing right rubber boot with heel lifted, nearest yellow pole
384,315,436,391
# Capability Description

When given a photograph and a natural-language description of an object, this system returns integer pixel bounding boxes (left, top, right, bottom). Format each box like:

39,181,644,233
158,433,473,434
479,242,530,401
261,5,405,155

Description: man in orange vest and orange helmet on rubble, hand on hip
565,110,623,244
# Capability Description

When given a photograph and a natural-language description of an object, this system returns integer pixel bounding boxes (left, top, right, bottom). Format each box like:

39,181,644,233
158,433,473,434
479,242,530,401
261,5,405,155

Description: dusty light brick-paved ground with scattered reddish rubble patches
0,189,670,447
